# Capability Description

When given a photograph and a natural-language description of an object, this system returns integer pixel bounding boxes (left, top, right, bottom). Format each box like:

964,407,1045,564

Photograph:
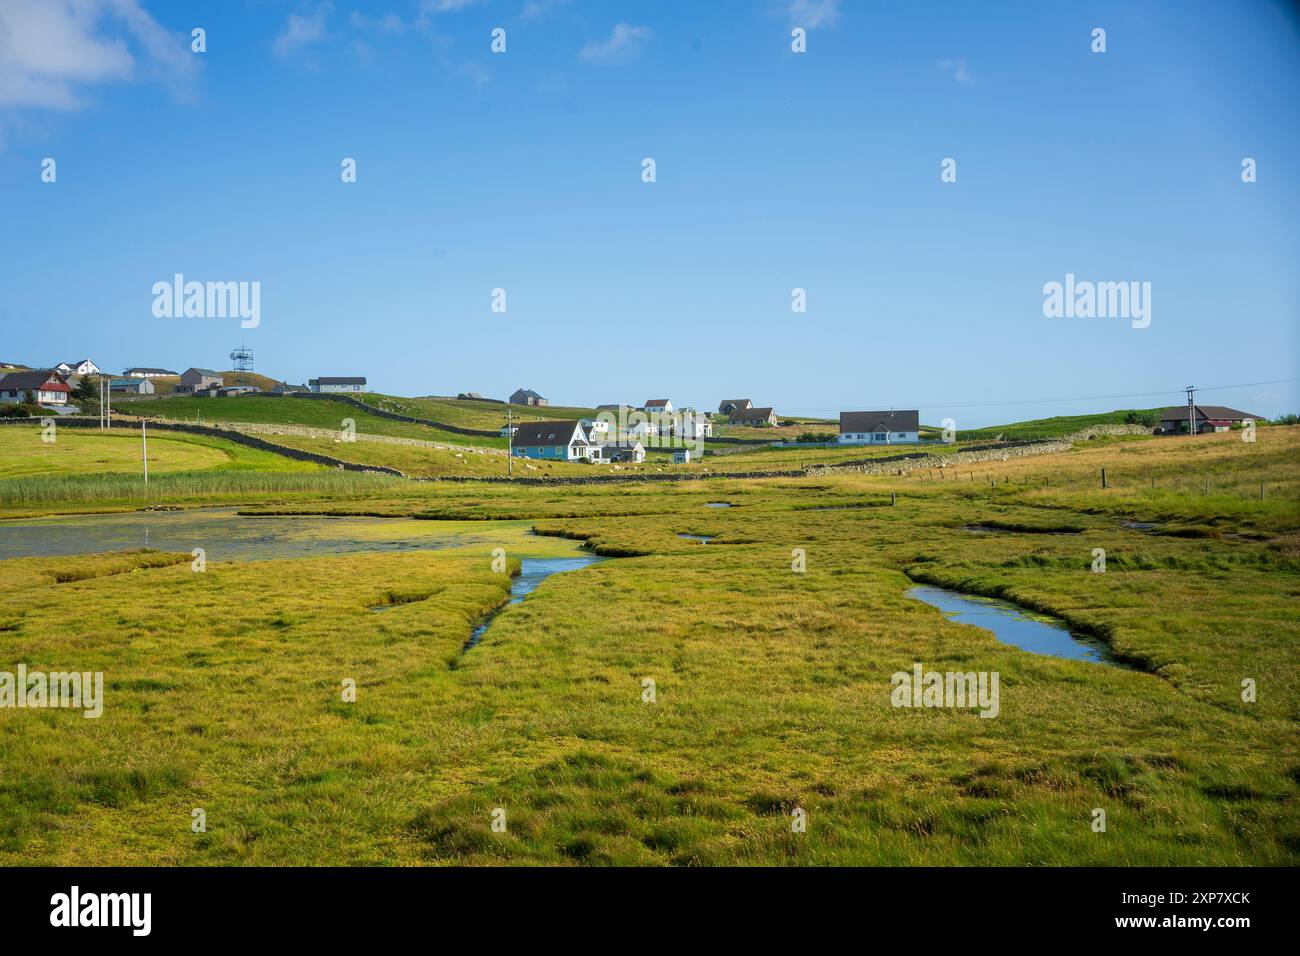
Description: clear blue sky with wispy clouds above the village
0,0,1300,427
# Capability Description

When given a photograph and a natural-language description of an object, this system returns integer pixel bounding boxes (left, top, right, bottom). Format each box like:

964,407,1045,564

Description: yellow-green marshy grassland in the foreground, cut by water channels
0,428,1300,865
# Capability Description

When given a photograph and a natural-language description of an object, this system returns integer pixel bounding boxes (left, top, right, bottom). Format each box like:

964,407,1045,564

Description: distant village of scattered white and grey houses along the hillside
0,352,1260,463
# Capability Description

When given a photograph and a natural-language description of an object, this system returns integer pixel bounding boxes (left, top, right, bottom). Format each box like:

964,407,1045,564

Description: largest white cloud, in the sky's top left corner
0,0,198,109
